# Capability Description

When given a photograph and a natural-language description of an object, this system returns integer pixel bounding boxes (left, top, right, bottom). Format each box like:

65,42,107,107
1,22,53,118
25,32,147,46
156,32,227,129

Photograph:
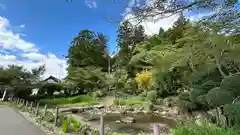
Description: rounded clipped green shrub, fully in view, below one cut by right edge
206,87,234,107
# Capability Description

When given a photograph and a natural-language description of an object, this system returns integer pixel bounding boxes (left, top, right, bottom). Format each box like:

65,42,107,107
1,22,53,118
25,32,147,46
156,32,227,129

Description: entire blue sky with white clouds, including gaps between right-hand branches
0,0,214,78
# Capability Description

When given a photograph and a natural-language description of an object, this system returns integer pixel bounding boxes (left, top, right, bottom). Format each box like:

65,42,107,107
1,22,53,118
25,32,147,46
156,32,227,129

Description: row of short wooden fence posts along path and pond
13,98,160,135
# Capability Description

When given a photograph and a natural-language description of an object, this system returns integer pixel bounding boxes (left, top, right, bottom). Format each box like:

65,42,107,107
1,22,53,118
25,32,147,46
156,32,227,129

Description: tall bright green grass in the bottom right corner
173,124,240,135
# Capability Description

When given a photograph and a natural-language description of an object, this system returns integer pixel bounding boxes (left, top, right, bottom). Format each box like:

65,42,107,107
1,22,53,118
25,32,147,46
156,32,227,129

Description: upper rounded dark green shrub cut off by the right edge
220,73,240,96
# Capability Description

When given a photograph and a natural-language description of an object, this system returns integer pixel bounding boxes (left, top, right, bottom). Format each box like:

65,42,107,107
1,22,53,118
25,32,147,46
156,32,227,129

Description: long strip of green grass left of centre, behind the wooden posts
39,95,94,106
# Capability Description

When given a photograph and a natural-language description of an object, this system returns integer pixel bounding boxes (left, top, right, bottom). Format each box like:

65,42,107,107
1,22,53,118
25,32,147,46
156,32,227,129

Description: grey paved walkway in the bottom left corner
0,105,45,135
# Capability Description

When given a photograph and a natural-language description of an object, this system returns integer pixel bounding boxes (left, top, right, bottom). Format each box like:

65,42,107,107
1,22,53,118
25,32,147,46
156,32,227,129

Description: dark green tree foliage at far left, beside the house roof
0,65,45,98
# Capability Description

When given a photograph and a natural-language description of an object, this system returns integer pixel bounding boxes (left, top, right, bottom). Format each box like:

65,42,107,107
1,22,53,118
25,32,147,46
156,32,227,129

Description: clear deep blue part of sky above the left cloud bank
0,0,128,56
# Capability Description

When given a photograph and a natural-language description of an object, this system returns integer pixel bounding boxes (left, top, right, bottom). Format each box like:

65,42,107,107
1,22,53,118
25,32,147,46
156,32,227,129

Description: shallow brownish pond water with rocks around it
78,112,176,135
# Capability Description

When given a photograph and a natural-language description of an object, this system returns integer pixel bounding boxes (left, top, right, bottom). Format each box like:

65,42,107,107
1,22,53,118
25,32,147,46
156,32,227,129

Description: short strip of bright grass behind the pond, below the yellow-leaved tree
114,97,148,105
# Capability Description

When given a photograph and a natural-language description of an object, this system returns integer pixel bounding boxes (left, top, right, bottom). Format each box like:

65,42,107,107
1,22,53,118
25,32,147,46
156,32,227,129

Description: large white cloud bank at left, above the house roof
0,16,67,78
